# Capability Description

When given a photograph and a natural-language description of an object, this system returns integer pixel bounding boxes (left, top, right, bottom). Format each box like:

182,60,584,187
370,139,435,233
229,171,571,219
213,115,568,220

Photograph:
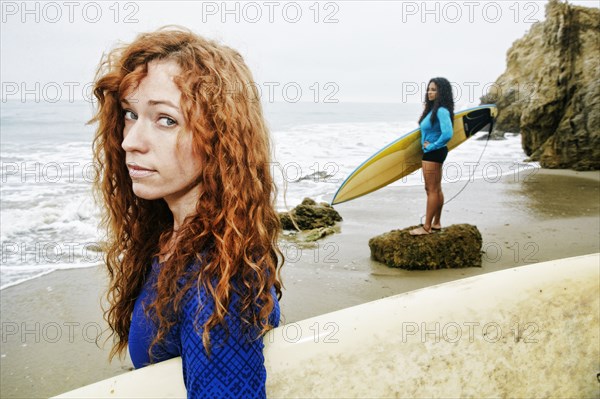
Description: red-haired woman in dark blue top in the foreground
91,27,283,397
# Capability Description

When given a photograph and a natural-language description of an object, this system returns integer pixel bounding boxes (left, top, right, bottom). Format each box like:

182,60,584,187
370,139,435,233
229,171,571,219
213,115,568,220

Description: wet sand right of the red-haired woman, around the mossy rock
282,169,600,322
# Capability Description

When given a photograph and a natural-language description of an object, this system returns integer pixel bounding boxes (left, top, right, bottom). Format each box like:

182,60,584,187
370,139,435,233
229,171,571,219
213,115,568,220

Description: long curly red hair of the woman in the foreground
89,26,283,359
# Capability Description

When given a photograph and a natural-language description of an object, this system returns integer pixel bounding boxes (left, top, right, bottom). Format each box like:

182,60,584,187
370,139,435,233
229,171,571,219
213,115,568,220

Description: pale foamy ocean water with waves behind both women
0,101,535,289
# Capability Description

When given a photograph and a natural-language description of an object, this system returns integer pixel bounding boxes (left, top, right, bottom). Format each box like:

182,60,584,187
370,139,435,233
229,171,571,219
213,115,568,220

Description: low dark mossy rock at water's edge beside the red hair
279,198,342,231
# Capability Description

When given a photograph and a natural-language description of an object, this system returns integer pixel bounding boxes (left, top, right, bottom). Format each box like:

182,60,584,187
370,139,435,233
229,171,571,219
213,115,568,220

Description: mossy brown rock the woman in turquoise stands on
369,224,483,270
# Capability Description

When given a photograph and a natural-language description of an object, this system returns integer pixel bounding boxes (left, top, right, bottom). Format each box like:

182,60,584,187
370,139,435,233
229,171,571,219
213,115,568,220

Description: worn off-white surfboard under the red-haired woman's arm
57,254,600,398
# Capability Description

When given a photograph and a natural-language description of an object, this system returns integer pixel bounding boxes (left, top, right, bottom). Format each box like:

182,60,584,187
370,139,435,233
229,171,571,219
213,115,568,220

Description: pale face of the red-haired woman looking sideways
121,61,201,205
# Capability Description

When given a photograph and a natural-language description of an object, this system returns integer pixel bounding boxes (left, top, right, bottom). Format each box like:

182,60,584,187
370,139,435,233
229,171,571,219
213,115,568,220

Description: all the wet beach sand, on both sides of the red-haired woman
0,170,600,398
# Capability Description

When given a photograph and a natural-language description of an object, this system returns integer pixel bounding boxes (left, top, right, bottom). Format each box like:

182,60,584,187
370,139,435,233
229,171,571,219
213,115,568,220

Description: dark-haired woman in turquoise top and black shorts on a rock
410,78,454,235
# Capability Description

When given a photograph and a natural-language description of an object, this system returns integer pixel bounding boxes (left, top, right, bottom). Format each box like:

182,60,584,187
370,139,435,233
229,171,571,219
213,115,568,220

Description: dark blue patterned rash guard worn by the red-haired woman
129,258,280,398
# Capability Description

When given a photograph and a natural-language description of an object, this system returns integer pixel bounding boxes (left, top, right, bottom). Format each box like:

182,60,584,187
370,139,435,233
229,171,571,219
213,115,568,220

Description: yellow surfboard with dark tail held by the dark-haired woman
331,104,498,205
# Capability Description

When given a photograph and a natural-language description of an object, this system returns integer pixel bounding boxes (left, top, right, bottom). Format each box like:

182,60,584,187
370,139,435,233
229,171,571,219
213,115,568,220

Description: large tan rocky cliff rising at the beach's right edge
482,0,600,170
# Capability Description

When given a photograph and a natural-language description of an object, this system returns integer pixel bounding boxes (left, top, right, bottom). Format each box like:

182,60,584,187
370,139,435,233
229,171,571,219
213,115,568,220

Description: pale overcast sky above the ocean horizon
1,0,598,104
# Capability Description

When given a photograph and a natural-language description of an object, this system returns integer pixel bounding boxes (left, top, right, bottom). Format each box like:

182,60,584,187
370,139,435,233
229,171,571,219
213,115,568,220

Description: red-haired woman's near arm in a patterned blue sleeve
180,288,266,398
